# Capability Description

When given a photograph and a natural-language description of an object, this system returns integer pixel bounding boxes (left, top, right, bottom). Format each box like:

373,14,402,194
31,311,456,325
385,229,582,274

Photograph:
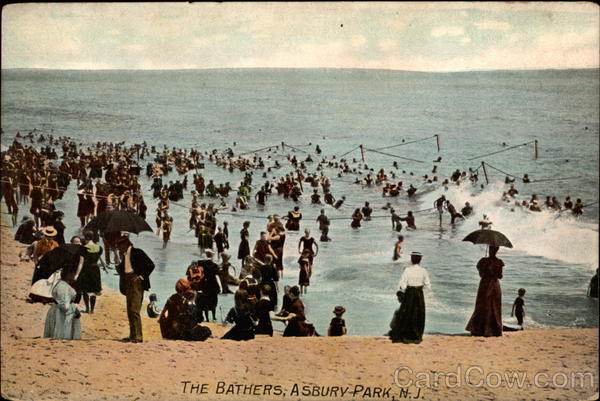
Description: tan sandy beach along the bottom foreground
1,221,598,401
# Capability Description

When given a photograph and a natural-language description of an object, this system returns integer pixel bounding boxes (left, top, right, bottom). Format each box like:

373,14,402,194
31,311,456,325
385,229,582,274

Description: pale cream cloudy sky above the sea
1,2,600,72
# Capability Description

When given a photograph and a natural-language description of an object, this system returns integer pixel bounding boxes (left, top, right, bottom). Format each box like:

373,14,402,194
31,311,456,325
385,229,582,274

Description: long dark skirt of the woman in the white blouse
389,287,425,344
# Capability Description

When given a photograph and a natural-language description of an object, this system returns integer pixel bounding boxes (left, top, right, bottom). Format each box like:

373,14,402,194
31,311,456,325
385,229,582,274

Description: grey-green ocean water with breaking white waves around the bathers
1,69,600,335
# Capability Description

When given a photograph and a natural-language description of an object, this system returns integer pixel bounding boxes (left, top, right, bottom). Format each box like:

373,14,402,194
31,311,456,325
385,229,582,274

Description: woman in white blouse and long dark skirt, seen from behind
388,252,431,344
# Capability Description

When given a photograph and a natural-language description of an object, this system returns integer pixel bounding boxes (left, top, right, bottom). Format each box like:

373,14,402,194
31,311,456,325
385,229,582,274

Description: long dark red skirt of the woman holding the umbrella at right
466,278,502,337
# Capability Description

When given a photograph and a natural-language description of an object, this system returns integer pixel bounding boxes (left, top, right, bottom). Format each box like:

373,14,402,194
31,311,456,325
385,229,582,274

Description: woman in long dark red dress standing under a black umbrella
466,246,504,337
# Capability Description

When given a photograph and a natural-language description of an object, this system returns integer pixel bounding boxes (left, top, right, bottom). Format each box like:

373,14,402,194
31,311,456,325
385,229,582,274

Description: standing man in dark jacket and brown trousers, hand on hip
116,236,154,343
